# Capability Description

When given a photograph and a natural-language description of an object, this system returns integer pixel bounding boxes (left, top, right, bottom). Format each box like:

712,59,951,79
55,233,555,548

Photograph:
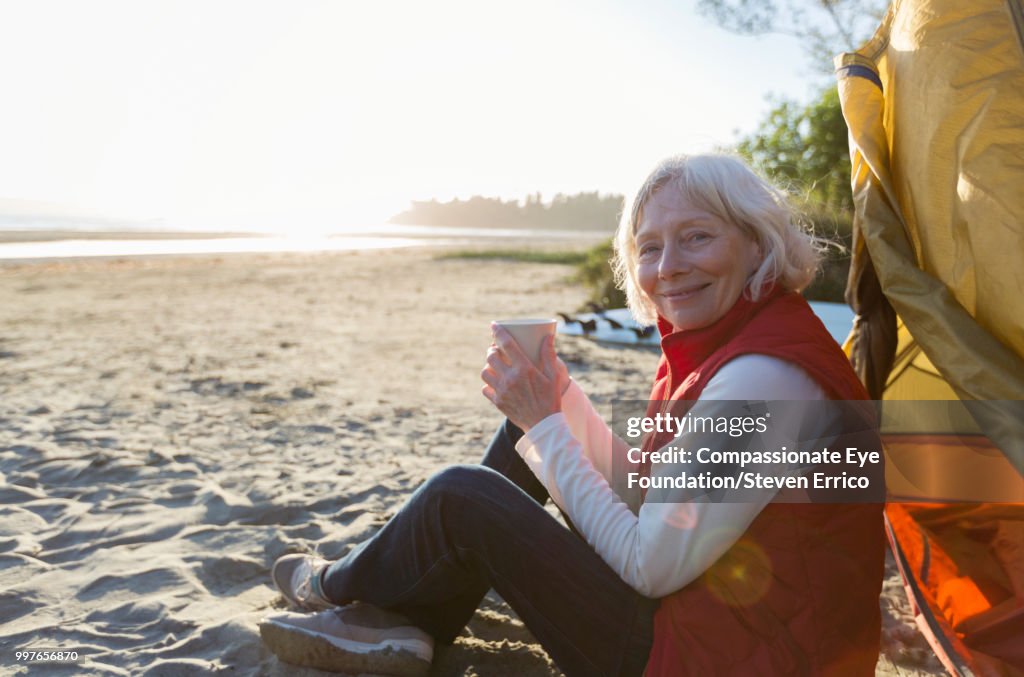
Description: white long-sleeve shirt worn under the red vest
516,354,825,597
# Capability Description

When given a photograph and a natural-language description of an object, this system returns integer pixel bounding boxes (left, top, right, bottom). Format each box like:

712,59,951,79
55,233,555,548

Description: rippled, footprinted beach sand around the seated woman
0,248,942,676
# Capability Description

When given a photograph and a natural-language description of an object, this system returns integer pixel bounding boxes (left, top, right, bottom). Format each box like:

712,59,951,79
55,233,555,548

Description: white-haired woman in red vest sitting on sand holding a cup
261,156,884,675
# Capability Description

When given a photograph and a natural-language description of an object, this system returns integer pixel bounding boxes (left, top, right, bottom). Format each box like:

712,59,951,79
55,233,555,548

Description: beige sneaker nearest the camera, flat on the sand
259,602,434,677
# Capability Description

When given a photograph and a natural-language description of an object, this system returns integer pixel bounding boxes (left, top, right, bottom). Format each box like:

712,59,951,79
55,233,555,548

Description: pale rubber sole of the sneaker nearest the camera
259,621,431,677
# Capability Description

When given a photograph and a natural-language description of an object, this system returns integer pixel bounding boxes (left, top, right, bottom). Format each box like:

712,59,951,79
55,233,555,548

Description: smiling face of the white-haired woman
635,186,761,331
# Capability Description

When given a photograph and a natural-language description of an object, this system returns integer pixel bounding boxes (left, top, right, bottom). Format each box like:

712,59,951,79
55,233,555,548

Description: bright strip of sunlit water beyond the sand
0,224,607,261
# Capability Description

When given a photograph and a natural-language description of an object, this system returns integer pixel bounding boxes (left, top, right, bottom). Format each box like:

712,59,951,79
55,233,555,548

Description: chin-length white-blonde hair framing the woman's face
611,155,824,324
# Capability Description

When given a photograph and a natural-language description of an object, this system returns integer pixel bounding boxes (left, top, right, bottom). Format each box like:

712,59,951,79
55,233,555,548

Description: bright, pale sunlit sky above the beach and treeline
0,0,822,230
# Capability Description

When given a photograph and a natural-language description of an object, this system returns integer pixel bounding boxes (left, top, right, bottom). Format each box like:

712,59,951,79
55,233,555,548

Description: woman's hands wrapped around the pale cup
480,325,569,430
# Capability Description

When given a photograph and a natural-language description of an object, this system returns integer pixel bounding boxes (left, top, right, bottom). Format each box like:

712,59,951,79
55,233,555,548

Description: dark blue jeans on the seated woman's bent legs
322,421,657,675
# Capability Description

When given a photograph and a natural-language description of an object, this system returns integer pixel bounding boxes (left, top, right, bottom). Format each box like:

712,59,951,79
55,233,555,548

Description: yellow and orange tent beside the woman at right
836,0,1024,675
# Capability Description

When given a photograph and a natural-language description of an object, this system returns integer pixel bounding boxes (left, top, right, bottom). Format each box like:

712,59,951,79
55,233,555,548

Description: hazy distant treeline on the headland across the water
390,192,623,232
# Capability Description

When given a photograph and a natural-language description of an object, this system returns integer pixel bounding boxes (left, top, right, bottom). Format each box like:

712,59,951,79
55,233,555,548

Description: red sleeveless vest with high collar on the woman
646,293,885,677
